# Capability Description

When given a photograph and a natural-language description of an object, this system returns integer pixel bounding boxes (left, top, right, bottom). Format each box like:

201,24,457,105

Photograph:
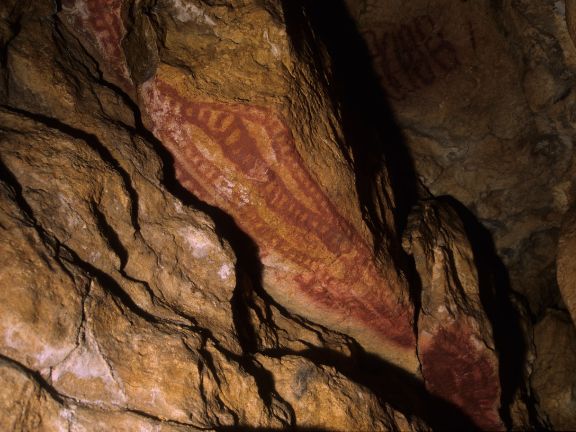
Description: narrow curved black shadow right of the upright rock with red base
438,196,542,429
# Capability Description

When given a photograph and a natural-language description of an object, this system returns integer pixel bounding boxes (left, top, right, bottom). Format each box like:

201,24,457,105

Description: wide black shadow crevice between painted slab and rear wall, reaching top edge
284,0,418,250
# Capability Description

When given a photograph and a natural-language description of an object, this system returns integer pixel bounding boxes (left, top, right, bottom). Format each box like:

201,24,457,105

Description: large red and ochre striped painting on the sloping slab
141,79,415,348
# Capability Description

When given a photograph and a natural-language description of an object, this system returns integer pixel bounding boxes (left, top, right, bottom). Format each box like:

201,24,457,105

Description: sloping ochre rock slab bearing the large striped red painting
56,1,417,373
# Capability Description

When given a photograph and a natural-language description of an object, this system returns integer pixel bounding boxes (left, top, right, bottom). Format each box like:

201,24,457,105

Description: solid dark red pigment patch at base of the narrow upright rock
419,324,504,431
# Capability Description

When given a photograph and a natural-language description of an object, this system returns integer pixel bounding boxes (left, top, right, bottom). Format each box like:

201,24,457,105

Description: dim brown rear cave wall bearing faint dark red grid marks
346,0,576,427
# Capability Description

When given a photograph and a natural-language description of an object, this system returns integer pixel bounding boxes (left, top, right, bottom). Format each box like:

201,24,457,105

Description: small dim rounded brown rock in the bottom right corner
531,310,576,430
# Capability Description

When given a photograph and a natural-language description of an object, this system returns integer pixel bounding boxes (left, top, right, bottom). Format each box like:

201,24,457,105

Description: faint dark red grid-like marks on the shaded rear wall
364,15,460,100
